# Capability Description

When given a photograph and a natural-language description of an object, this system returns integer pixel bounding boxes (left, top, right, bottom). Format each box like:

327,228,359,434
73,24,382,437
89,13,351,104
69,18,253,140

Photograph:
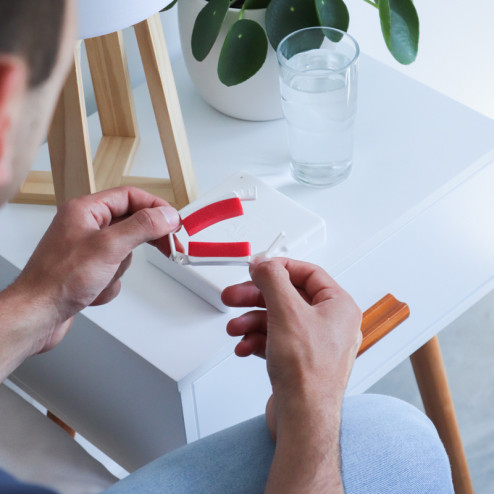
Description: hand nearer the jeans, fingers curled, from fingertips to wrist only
223,259,362,420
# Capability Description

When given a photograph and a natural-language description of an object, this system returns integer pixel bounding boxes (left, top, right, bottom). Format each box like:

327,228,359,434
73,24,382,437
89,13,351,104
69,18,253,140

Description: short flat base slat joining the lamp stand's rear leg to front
93,136,139,190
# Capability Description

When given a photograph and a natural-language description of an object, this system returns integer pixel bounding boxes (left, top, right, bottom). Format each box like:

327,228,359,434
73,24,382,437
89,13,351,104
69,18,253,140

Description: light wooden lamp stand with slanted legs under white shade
13,14,197,208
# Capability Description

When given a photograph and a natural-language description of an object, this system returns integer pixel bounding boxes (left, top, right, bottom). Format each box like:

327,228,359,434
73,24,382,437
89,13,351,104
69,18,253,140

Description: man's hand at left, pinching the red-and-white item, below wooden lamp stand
12,187,180,352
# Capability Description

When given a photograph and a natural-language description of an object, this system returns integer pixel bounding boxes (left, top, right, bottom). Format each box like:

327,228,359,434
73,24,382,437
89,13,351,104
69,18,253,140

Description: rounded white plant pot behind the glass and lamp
178,0,283,120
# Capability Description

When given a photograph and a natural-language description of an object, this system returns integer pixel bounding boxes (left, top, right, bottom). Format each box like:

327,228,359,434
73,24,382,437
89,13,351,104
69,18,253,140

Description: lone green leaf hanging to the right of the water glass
379,0,419,65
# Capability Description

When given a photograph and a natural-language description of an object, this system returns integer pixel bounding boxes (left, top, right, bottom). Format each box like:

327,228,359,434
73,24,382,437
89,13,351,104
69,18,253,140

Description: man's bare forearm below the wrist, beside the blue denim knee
265,405,344,494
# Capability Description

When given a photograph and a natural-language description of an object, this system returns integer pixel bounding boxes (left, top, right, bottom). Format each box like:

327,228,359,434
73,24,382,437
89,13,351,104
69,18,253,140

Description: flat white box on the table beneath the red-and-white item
146,172,326,312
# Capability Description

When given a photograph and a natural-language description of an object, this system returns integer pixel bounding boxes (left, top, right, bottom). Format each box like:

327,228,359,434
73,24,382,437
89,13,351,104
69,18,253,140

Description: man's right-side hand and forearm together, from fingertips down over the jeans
222,259,362,494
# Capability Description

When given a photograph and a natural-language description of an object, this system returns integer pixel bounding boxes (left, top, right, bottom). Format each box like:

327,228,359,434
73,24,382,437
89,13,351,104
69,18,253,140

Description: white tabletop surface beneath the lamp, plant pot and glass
0,56,494,381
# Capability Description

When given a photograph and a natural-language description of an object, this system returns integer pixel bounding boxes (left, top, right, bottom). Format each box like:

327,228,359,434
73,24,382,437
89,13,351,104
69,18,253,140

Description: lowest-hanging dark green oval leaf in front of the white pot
218,19,268,86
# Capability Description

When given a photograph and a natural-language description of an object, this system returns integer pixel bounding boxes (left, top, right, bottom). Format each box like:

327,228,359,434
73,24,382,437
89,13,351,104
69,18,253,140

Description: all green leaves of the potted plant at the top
163,0,419,86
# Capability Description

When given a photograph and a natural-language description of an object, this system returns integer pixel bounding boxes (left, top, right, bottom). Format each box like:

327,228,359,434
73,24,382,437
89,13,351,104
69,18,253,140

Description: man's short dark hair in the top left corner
0,0,65,87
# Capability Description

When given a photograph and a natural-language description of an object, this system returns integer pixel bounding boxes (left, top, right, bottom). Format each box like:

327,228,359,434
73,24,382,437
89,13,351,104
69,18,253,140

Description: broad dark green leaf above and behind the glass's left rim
266,0,320,50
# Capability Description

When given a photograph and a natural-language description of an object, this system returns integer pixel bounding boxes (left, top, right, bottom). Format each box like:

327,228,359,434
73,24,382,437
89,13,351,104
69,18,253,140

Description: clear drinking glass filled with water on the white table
276,27,359,187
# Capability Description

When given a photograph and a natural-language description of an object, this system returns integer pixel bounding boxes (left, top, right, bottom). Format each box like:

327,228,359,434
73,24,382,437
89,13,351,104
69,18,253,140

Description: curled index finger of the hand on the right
262,258,342,304
